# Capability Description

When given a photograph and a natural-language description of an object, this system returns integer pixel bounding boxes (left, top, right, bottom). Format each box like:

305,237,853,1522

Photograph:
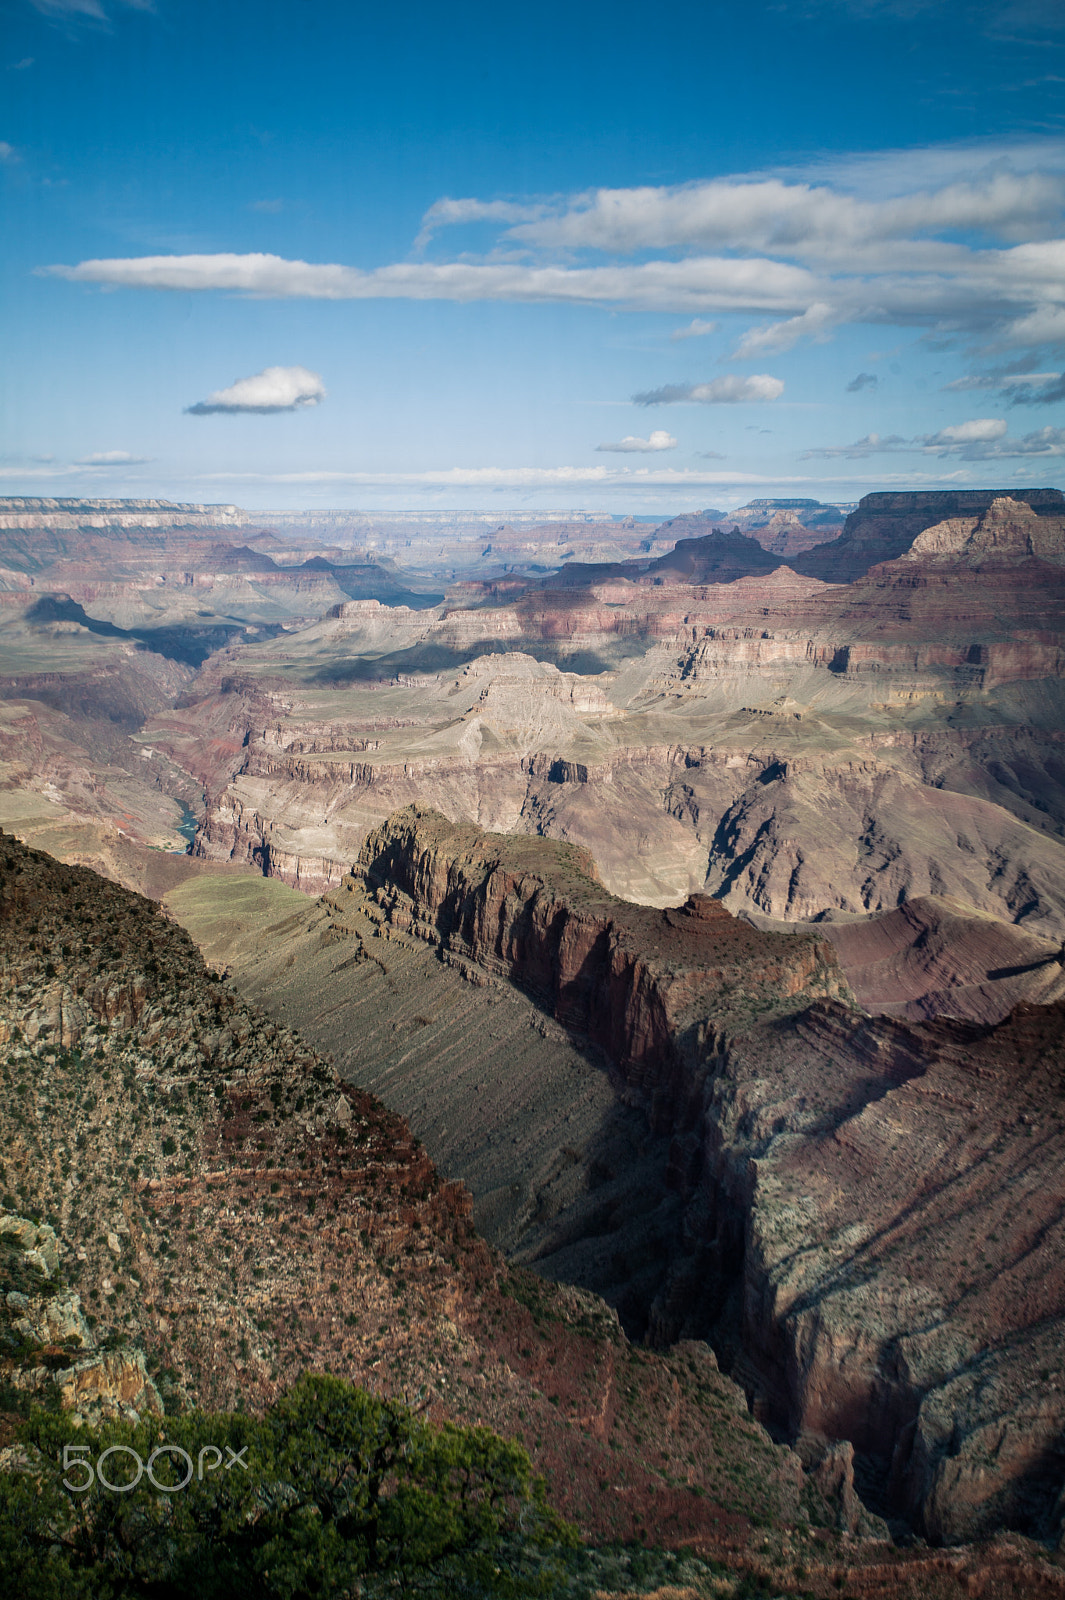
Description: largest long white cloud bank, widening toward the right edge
38,144,1065,366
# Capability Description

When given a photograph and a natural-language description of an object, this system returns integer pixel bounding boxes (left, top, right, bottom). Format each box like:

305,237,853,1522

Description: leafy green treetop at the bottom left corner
0,1376,576,1600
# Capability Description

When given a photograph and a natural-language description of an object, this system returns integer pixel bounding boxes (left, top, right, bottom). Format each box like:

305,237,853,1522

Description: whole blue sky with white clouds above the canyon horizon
0,0,1065,517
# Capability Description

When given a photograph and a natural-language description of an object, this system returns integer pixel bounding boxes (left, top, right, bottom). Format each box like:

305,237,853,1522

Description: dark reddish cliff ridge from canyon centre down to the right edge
357,808,1065,1539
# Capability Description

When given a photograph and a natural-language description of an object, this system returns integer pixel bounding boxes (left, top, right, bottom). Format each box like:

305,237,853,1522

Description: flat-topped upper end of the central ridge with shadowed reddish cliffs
357,806,849,1122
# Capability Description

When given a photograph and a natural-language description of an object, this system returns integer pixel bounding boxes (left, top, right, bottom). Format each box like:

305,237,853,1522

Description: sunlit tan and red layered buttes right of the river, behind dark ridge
152,496,1065,939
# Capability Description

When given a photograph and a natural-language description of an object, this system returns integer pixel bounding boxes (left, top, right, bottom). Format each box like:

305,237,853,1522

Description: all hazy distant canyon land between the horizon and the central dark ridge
0,488,1065,1014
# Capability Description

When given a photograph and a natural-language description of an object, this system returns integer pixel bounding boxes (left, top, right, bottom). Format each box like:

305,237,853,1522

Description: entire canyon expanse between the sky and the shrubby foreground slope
0,490,1065,1592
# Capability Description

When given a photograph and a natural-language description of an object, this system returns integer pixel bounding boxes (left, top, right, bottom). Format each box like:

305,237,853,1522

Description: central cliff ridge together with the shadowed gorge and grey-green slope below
178,808,1065,1542
